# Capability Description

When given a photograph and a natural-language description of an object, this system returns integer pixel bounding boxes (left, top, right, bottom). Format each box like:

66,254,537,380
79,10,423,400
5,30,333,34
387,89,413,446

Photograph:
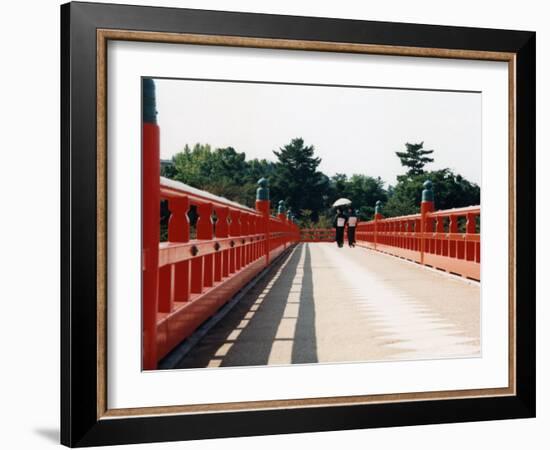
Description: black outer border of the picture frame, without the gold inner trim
60,2,536,447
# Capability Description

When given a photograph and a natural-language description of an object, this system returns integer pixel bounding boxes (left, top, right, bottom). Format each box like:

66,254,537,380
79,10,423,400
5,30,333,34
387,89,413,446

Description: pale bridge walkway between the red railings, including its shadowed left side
178,243,480,368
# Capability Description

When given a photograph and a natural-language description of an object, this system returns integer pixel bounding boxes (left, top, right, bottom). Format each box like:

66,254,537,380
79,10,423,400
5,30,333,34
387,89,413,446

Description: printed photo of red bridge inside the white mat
141,77,483,370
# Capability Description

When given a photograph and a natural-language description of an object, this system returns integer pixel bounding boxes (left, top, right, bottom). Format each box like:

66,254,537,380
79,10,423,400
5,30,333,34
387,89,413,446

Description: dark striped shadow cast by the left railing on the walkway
178,245,317,368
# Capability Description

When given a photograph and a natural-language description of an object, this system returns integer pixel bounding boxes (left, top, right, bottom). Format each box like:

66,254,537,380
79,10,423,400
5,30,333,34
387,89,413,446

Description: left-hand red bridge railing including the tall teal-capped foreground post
142,78,300,370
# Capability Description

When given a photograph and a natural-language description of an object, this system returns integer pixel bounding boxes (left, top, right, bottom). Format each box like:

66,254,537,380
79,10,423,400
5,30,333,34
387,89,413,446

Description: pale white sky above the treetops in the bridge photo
156,80,481,184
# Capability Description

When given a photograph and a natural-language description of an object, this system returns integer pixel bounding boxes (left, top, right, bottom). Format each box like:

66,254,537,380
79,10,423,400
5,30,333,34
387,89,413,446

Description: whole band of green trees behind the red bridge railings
163,138,480,228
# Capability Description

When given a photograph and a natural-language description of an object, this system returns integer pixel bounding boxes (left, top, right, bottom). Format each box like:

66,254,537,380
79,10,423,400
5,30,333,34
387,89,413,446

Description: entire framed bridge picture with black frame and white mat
61,2,536,447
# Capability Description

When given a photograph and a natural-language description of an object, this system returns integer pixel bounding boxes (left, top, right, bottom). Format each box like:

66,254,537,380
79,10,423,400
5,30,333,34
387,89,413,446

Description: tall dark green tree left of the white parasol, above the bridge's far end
270,138,329,221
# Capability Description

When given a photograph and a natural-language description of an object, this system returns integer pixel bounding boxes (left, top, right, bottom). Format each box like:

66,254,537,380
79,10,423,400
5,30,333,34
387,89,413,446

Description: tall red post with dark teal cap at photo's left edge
142,78,160,370
